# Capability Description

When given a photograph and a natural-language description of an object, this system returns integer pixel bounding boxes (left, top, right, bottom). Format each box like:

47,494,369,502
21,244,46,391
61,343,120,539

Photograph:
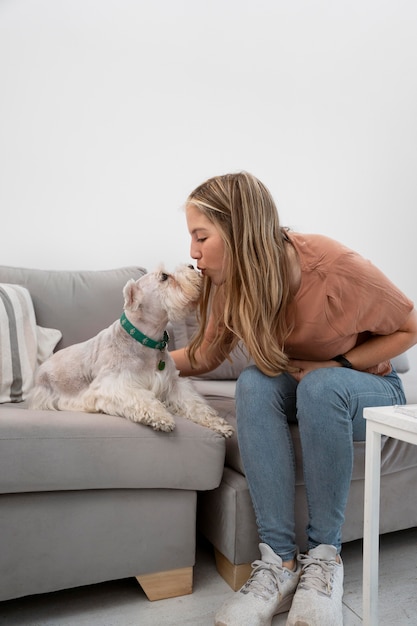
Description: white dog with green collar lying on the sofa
29,265,234,437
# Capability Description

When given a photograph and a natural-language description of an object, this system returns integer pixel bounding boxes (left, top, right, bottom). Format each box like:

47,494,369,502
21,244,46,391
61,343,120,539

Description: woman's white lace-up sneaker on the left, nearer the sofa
215,543,301,626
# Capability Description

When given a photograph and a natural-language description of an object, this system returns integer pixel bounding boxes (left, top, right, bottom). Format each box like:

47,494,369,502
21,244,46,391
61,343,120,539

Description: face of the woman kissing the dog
185,203,226,285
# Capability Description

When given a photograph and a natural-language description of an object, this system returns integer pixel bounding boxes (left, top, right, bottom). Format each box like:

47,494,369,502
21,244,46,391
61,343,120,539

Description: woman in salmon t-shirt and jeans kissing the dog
172,172,417,626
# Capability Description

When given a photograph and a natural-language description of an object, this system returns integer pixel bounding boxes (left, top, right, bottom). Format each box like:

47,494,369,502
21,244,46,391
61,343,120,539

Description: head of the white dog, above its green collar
123,264,202,321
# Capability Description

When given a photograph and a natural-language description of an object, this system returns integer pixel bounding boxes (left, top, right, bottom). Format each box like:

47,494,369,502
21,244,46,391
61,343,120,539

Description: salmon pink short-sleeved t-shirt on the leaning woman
285,231,413,375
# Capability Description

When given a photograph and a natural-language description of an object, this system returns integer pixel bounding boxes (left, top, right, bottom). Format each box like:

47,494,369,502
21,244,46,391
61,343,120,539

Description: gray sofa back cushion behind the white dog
0,266,146,349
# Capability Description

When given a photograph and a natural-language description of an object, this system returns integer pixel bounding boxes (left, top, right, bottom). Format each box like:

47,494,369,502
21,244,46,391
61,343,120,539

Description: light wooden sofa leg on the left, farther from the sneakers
136,567,193,601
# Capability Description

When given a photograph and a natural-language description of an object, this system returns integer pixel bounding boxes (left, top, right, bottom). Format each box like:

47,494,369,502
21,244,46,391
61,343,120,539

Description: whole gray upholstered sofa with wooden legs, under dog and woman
0,267,417,600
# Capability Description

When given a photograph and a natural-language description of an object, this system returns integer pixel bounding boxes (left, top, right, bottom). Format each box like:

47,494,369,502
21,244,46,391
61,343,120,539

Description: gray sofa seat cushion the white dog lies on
0,404,225,493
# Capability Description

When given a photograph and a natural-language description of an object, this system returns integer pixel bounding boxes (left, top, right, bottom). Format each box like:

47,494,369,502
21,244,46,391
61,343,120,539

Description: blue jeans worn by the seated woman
236,365,405,561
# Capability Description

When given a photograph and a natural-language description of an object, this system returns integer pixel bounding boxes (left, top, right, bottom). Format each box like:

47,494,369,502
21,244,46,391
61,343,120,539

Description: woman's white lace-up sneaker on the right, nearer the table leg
287,544,343,626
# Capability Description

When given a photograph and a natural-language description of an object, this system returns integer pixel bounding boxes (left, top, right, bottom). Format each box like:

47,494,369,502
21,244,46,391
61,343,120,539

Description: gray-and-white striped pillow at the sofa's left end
0,283,38,402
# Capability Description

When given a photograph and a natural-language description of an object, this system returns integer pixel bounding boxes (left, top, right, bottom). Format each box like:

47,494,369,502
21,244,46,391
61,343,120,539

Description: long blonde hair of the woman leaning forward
186,172,291,376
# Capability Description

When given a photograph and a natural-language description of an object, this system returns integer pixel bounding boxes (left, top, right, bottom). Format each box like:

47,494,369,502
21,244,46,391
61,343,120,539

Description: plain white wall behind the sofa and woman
0,0,417,360
